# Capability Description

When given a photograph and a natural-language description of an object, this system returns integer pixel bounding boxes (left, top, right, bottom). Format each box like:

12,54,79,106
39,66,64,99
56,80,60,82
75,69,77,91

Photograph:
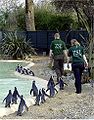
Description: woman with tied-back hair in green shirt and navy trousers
67,39,88,94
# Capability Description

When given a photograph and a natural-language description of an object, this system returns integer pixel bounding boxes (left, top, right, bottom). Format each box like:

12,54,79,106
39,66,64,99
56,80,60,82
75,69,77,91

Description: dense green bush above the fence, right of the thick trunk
35,9,76,30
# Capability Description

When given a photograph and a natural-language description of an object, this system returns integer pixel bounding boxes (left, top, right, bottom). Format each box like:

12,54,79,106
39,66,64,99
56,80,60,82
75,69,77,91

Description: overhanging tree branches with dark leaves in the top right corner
51,0,91,31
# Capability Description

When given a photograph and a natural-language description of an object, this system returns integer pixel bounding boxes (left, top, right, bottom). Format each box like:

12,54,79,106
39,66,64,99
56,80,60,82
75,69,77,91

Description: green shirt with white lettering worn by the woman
69,45,84,63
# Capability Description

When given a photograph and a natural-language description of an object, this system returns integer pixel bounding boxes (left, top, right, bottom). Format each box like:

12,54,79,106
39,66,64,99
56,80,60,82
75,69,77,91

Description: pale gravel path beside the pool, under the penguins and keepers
3,57,94,119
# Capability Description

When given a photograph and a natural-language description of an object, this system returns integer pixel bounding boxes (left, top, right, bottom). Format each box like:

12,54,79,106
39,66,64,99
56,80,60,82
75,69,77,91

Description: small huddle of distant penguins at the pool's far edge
16,64,35,76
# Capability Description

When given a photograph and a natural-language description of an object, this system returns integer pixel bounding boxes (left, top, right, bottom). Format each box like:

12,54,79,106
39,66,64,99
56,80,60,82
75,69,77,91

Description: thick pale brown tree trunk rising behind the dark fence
25,0,35,31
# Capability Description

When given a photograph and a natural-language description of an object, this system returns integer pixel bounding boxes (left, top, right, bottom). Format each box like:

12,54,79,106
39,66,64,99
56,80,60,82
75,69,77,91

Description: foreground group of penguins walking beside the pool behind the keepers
3,76,67,116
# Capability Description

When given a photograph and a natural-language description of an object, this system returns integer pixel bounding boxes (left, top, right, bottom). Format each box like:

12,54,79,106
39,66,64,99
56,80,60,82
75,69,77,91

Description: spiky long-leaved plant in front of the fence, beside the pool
0,32,36,59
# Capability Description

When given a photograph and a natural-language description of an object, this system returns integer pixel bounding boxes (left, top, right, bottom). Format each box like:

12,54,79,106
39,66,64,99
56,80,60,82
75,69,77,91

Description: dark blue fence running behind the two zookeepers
0,30,89,52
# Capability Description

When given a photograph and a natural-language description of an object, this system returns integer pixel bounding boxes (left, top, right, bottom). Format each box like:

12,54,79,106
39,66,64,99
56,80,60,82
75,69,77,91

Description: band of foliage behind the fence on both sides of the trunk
0,0,90,30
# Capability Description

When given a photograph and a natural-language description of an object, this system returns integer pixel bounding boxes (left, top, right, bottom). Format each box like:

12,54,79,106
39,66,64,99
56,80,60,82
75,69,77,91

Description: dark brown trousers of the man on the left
54,59,64,80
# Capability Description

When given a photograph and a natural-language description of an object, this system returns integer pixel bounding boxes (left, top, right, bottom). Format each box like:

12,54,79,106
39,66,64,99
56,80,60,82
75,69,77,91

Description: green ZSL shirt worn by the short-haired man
50,39,67,56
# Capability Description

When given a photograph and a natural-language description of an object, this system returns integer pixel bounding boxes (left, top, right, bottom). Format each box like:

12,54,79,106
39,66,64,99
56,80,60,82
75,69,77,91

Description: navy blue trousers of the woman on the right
72,63,84,93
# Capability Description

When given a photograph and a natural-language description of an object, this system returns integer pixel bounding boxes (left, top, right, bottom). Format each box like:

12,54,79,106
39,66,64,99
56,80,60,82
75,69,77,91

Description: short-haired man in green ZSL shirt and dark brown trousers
49,33,68,81
